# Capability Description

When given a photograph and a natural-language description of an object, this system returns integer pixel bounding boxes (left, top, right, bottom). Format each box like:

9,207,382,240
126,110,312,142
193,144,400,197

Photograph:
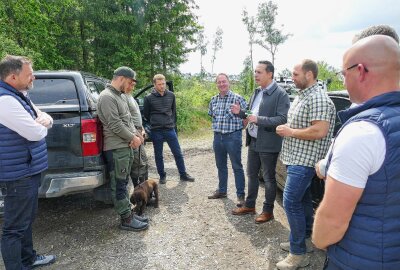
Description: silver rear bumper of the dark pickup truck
39,171,106,198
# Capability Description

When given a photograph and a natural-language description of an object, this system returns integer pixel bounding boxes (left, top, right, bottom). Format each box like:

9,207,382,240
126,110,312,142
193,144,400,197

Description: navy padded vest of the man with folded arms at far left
0,81,47,181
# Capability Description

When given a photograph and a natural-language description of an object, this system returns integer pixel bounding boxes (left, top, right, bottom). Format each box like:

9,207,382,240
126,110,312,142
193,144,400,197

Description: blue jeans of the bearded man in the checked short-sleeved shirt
283,165,315,255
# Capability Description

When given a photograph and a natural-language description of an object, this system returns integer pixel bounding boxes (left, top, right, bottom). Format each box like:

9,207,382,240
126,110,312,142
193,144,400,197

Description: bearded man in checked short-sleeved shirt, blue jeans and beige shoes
276,60,335,269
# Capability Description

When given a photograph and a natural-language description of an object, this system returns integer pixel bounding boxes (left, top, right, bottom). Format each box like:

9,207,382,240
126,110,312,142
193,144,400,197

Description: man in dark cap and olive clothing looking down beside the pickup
97,67,149,231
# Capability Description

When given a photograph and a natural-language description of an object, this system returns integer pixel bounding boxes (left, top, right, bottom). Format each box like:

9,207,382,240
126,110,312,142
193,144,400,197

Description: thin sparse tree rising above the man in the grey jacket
256,1,291,64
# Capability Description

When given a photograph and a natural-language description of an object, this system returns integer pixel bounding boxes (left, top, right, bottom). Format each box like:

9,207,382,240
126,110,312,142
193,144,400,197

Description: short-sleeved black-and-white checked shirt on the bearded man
280,84,336,167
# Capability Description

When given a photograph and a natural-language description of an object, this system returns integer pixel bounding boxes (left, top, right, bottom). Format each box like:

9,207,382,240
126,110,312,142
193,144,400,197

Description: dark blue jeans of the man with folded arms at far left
0,174,41,270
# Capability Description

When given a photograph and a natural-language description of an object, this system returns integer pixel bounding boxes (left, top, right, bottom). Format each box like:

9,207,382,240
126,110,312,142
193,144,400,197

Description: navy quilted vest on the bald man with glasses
328,92,400,270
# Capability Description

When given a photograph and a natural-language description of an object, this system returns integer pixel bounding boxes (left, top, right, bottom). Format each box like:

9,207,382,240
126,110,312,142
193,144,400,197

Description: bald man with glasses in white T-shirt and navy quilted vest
312,35,400,270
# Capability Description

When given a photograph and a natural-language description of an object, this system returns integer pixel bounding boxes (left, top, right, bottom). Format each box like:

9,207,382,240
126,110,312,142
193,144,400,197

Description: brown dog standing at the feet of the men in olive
131,179,158,216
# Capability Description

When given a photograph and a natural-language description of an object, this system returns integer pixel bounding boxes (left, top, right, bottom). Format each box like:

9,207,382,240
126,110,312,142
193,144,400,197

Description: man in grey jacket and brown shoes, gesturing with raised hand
232,61,290,223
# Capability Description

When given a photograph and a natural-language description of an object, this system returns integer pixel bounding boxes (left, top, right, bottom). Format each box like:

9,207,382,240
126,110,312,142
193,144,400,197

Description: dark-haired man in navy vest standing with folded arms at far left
0,55,55,270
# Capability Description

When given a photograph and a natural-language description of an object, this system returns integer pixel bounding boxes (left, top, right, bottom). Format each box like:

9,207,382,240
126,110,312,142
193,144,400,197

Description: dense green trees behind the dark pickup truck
0,0,200,80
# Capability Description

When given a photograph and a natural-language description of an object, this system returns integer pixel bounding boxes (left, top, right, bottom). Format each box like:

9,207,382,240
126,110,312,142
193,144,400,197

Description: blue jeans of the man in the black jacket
151,129,186,177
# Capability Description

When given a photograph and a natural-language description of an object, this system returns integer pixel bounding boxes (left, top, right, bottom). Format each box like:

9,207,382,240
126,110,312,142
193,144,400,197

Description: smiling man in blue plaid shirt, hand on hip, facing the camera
208,73,247,207
